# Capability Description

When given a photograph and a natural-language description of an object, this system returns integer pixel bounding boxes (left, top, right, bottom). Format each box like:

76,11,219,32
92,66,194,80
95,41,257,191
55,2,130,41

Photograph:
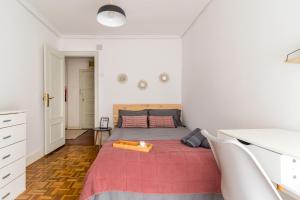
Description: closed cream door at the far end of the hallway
79,70,95,128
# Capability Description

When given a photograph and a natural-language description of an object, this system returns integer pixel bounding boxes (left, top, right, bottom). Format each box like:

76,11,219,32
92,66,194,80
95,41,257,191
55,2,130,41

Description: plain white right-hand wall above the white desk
183,0,300,132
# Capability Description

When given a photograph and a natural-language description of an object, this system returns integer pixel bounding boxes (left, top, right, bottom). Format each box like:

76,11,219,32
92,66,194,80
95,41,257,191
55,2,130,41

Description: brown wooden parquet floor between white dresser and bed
17,145,98,200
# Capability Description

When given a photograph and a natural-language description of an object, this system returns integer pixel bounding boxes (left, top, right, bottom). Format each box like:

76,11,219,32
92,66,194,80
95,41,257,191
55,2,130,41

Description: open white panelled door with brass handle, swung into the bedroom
44,46,65,154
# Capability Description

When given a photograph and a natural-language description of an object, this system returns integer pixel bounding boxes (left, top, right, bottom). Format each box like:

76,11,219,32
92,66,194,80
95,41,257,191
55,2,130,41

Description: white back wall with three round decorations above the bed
60,39,182,123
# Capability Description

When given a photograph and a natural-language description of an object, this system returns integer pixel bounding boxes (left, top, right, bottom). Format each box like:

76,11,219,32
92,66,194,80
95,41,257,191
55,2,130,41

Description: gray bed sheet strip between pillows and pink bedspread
108,127,190,141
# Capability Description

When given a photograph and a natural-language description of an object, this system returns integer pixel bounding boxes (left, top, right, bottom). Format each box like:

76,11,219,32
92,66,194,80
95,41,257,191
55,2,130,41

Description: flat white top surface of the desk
218,129,300,159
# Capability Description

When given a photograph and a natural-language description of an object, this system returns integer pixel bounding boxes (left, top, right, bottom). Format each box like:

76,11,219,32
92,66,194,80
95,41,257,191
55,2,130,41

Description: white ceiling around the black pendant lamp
27,0,209,36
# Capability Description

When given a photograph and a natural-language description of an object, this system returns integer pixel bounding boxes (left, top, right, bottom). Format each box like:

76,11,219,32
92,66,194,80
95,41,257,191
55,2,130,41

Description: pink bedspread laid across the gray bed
80,140,221,200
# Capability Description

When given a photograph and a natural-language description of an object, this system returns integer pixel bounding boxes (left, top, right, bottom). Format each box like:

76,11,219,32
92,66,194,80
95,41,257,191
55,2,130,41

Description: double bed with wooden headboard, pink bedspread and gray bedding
80,104,223,200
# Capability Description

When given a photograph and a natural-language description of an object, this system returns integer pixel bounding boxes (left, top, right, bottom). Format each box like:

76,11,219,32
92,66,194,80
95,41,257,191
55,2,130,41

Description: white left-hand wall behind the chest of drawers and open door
0,0,58,165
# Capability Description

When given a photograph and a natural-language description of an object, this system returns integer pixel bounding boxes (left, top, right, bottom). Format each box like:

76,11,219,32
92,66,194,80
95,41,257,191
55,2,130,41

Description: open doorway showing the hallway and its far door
65,57,95,145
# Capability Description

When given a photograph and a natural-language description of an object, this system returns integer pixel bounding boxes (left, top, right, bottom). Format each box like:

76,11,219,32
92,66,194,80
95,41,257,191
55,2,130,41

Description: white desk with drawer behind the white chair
218,129,300,199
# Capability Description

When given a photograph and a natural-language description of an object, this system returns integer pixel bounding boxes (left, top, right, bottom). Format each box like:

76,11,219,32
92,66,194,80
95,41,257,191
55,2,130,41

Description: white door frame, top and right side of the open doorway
62,51,100,128
